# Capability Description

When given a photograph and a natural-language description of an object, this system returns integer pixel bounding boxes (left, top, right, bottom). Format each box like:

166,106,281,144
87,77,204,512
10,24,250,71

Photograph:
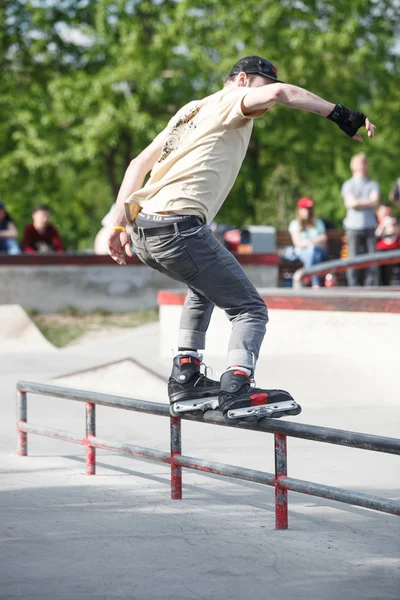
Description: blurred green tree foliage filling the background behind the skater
0,0,400,249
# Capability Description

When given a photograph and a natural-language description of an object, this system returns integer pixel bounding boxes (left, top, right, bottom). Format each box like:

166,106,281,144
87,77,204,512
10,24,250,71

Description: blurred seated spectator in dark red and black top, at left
22,205,64,254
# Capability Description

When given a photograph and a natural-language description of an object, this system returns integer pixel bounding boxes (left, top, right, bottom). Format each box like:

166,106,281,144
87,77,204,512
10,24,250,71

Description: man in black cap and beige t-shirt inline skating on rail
108,56,375,423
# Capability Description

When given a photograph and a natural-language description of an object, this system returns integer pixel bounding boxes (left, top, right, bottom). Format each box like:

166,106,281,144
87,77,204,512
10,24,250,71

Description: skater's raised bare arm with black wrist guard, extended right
242,83,375,142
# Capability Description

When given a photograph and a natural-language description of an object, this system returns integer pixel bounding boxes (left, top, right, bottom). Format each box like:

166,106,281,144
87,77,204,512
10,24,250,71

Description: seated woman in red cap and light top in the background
289,198,328,288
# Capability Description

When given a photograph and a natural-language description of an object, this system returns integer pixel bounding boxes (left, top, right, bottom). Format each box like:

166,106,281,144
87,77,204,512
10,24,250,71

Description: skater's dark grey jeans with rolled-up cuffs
132,224,268,369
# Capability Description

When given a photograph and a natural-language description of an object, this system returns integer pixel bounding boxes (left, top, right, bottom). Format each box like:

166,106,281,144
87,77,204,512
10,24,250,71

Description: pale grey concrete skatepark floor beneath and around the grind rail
0,308,400,600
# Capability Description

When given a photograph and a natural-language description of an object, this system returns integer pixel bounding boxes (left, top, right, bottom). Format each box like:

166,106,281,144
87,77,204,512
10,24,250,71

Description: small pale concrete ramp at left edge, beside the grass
0,304,55,352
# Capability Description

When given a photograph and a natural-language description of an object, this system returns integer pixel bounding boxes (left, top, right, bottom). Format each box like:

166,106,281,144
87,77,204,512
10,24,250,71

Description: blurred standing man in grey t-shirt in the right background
342,152,380,287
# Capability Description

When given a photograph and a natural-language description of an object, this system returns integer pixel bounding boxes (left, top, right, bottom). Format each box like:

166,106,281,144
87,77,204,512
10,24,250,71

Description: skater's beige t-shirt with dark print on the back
125,87,264,223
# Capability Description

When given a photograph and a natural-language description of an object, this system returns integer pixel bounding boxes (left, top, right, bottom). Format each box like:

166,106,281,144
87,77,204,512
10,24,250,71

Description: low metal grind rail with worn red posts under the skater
17,381,400,529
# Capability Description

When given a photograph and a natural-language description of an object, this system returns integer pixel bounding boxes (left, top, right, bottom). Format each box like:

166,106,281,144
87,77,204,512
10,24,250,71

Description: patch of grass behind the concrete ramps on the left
26,307,158,348
